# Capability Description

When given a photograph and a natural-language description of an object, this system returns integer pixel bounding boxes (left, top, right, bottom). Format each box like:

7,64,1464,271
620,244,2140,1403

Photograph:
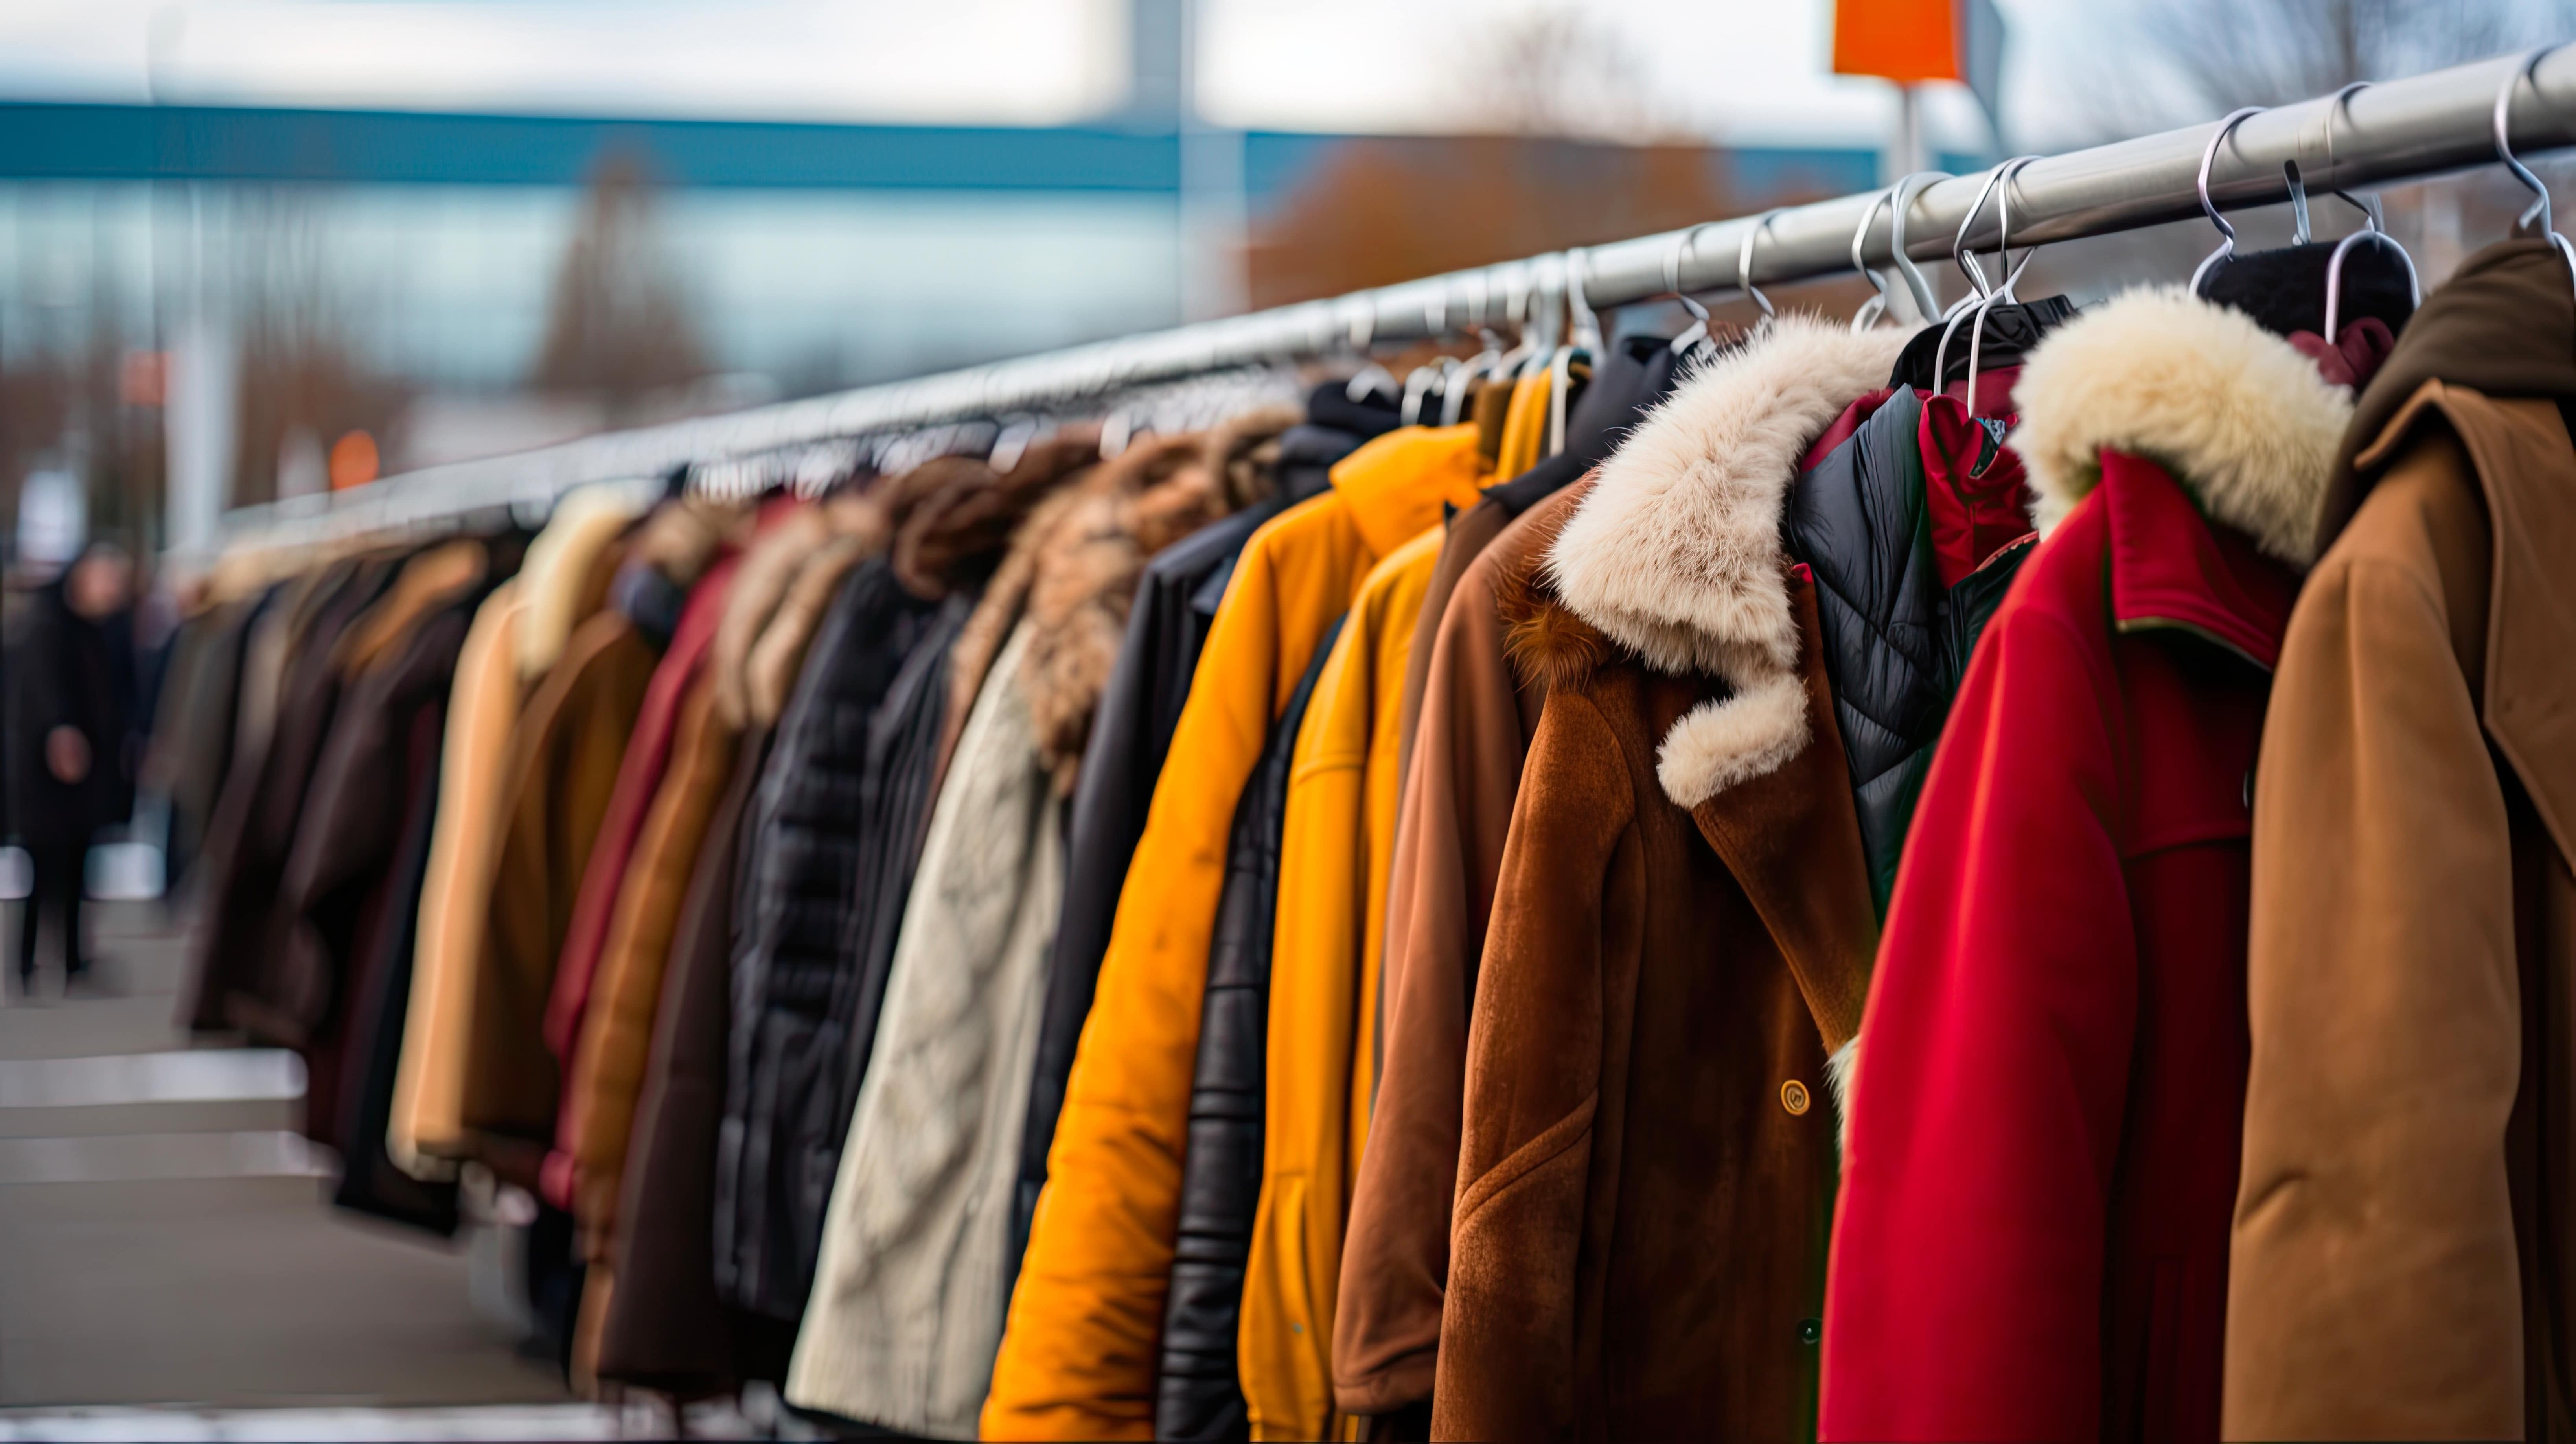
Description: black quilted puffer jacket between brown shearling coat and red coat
1783,387,2030,913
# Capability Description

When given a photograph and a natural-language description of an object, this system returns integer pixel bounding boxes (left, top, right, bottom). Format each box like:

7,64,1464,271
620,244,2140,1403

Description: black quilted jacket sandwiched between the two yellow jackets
1154,611,1342,1439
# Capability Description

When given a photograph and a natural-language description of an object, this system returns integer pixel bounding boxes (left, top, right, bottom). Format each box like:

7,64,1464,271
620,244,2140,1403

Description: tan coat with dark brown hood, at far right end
2223,240,2576,1439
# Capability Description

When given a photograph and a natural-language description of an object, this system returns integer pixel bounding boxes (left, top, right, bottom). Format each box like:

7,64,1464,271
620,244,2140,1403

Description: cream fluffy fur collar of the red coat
2012,286,2352,567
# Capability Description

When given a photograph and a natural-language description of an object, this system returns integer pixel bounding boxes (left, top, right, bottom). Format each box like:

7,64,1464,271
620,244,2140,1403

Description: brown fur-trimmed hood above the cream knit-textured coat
940,407,1301,794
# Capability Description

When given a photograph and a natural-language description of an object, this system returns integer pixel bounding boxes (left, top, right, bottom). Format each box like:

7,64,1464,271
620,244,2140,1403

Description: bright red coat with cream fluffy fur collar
1821,289,2352,1439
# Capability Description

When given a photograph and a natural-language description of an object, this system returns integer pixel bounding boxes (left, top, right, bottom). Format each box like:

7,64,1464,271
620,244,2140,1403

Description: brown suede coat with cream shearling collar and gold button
1432,317,1896,1439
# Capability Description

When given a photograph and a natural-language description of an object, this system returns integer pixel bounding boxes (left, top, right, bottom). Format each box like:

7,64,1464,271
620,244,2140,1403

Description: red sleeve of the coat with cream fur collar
1819,595,2138,1439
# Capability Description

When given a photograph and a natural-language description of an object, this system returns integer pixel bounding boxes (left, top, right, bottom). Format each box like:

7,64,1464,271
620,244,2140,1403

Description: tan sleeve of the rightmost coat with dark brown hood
2223,451,2524,1439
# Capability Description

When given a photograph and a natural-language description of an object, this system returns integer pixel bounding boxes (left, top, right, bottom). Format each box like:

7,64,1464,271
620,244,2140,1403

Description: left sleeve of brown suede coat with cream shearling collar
1432,691,1641,1439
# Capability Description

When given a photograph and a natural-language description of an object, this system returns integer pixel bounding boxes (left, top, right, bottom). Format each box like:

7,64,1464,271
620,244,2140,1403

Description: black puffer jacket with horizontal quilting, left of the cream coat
716,557,940,1318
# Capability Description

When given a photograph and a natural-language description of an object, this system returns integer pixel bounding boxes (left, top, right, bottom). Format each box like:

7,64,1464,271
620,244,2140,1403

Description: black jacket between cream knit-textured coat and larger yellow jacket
1005,425,1360,1264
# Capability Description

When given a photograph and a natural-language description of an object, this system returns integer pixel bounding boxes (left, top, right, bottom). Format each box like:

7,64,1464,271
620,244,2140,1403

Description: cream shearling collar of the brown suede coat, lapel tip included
1548,315,1906,807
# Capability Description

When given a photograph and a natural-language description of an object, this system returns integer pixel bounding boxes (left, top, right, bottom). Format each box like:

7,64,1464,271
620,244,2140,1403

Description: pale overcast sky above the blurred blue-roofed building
0,0,2097,147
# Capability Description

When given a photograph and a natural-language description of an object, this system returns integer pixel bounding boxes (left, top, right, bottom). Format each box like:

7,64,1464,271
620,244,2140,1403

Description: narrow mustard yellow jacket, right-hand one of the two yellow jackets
1236,526,1440,1439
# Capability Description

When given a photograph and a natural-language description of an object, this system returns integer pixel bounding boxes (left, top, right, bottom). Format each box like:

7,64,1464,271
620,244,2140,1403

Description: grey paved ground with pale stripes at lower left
0,905,574,1413
